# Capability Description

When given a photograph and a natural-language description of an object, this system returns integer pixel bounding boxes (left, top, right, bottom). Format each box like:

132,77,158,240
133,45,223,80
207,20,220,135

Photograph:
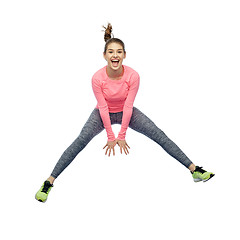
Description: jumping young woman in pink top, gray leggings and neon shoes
35,24,214,202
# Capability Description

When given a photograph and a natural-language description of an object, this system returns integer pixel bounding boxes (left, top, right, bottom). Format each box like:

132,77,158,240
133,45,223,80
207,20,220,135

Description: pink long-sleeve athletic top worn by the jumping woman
92,65,140,141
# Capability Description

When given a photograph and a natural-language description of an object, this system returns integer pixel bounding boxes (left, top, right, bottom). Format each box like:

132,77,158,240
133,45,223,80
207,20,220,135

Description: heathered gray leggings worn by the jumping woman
51,107,192,178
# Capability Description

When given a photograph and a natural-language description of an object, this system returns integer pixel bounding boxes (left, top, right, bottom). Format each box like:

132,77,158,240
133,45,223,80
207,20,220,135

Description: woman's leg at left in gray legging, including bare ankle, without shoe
48,108,104,184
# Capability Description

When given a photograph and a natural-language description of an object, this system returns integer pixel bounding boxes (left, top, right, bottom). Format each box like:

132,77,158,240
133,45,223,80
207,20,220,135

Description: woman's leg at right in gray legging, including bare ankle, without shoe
129,107,195,171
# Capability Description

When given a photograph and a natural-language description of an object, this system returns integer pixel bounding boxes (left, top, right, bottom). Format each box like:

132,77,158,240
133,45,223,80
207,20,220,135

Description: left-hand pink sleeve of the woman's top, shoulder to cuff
92,78,115,141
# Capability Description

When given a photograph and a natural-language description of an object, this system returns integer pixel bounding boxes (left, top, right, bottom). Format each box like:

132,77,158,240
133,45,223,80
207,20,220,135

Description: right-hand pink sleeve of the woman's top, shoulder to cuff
117,73,140,140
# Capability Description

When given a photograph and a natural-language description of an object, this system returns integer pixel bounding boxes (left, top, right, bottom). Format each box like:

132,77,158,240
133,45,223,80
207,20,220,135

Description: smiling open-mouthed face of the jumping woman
103,43,126,71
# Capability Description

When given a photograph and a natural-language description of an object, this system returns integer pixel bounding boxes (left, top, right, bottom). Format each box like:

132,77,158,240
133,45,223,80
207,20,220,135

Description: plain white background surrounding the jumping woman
0,0,240,240
